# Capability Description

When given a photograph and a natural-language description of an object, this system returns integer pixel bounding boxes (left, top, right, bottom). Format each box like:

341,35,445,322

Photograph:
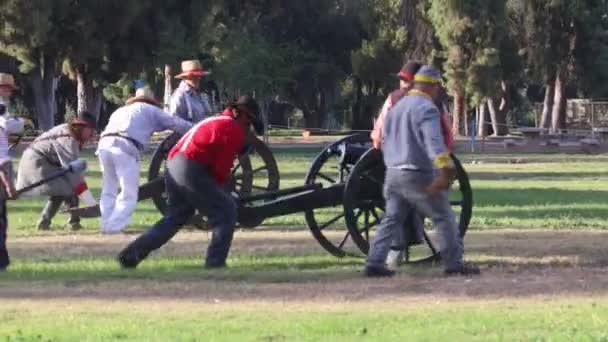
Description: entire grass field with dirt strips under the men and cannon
0,148,608,341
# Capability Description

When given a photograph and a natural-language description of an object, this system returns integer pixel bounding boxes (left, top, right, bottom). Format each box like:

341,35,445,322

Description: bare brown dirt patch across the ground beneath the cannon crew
0,230,608,302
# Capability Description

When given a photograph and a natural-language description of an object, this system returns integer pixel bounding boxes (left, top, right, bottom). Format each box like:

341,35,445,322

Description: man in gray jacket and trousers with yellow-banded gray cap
364,66,479,277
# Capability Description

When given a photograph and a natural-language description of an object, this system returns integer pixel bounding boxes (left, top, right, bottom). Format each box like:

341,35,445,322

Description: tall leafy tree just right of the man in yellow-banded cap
428,0,506,135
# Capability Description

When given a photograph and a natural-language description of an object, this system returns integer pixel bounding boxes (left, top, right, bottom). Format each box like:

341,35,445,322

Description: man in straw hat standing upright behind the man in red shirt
169,60,212,123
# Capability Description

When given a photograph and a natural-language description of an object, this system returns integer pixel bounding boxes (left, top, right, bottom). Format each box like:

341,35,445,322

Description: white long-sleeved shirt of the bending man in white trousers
97,102,192,159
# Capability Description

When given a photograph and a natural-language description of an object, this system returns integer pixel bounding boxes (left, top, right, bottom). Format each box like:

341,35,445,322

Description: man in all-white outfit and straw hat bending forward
97,87,192,234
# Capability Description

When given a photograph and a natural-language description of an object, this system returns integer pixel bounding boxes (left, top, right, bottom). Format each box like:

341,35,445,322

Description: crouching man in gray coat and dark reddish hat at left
17,112,97,230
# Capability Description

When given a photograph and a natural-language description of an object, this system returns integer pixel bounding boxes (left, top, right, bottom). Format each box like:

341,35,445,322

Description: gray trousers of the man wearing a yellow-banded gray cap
367,168,463,269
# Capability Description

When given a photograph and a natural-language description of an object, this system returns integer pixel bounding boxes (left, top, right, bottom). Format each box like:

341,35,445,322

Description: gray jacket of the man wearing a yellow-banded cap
382,95,448,172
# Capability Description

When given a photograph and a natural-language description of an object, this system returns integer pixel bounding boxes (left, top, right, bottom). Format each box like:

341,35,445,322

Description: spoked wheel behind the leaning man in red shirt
148,133,280,229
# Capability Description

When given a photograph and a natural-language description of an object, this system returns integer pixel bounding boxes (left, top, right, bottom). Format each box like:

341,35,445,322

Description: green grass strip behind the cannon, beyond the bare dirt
9,148,608,234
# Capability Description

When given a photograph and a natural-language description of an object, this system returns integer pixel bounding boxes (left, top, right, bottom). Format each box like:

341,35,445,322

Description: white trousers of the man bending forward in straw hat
98,147,139,233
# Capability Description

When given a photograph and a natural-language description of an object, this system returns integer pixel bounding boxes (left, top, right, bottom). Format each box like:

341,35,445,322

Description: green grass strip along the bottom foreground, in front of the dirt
0,298,608,341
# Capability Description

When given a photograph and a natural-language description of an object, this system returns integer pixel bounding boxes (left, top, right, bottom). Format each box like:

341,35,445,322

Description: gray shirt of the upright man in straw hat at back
169,81,211,123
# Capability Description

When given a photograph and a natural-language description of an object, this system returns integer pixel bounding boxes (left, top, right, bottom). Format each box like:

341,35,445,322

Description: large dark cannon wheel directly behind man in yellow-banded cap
344,149,473,263
